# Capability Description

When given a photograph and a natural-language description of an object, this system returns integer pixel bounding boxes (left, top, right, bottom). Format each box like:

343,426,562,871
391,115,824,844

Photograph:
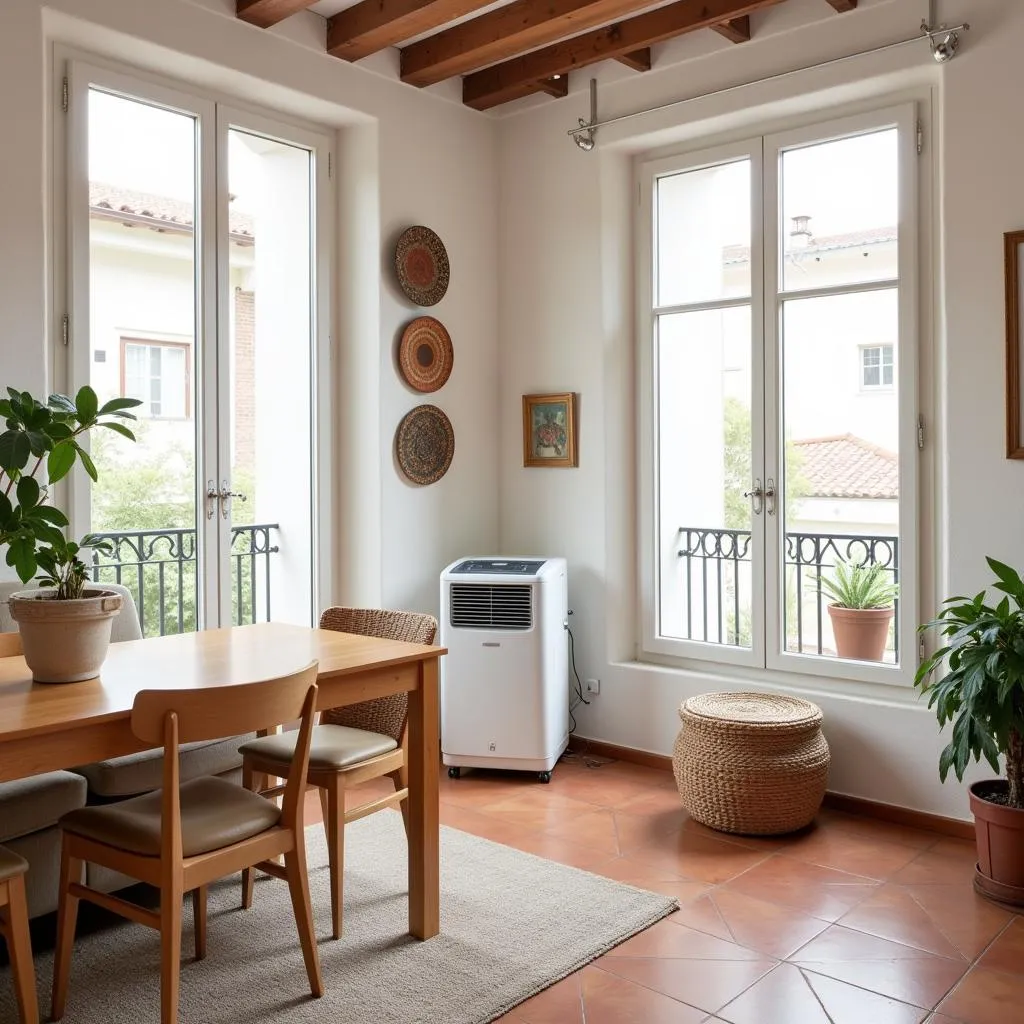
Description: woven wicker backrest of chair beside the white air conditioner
321,607,437,745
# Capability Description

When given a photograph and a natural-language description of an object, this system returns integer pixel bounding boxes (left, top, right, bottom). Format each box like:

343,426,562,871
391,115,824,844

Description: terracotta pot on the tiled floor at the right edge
970,779,1024,906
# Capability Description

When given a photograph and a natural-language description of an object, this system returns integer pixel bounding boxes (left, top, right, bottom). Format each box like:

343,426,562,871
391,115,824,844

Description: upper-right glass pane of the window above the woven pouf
779,128,899,292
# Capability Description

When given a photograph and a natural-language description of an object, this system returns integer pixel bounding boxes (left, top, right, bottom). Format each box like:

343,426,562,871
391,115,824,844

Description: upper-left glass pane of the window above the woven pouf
655,160,751,306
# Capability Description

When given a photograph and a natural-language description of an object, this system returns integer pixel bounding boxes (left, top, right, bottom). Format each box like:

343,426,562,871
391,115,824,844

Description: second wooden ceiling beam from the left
327,0,490,60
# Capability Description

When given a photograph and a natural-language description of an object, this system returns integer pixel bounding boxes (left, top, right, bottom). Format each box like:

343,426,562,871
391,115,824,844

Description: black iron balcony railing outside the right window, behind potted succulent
675,526,899,660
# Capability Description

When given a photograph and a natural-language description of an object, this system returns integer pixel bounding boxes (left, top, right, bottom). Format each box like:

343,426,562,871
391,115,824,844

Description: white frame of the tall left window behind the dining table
58,56,337,629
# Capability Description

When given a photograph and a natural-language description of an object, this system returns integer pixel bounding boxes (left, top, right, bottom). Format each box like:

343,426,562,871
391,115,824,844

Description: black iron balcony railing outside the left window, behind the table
92,523,279,637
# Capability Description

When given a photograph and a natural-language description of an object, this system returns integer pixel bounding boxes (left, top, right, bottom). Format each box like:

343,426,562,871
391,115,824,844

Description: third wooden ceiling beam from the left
401,0,667,86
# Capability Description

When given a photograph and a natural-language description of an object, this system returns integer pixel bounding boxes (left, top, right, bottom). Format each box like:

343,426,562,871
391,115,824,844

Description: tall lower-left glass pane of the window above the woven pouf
657,306,753,648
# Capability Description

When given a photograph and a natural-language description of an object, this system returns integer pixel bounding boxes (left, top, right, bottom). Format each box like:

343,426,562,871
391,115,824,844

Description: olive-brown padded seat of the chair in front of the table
60,778,281,857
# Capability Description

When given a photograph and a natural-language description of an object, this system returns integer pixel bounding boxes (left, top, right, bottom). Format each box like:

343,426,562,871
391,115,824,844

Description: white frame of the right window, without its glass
637,102,926,687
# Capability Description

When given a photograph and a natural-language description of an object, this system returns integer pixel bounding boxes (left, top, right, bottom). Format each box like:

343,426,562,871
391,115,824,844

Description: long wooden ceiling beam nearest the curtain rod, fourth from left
462,0,782,111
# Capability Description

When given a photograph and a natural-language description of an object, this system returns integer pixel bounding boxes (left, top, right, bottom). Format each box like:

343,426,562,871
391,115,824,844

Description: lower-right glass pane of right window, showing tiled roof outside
779,289,900,664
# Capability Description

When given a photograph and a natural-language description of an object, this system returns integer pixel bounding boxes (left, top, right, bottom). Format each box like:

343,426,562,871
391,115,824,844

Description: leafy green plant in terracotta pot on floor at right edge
914,558,1024,906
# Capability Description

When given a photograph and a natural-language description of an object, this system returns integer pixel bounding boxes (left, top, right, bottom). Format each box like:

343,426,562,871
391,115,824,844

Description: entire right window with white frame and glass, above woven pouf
639,106,918,684
